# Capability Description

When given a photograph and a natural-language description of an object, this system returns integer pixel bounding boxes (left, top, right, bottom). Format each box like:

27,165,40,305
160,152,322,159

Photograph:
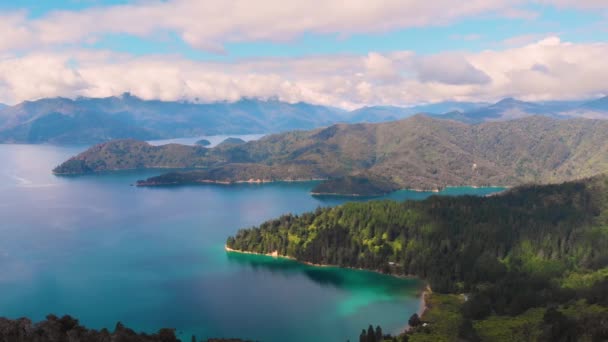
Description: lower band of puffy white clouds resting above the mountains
0,37,608,108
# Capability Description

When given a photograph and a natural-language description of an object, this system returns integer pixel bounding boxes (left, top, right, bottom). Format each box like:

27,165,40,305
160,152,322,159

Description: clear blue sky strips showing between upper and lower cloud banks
0,0,608,60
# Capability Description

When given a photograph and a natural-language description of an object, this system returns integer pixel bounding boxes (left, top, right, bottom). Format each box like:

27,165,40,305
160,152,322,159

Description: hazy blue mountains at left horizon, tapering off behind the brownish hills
0,94,345,143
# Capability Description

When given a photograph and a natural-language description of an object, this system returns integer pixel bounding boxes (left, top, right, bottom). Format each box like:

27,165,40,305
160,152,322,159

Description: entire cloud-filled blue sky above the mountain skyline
0,0,608,109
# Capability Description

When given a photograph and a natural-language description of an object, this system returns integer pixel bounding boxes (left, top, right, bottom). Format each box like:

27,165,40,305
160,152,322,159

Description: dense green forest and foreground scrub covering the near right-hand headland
227,176,608,341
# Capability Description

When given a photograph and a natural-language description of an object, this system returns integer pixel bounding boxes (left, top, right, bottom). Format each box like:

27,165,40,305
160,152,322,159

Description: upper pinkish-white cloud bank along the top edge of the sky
0,0,522,52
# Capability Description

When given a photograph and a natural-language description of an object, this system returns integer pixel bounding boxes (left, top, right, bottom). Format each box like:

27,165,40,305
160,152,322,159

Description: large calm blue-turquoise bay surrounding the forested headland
0,145,500,342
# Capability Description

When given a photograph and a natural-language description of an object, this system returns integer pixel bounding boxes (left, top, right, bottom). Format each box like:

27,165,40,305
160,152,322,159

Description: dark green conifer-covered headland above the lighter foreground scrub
227,176,608,292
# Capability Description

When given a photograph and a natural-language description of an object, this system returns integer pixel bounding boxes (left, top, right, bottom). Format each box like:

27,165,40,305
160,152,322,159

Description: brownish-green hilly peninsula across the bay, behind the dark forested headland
54,115,608,195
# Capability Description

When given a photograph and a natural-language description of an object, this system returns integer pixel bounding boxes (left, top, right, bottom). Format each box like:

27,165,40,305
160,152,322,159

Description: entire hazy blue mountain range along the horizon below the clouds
0,94,608,144
